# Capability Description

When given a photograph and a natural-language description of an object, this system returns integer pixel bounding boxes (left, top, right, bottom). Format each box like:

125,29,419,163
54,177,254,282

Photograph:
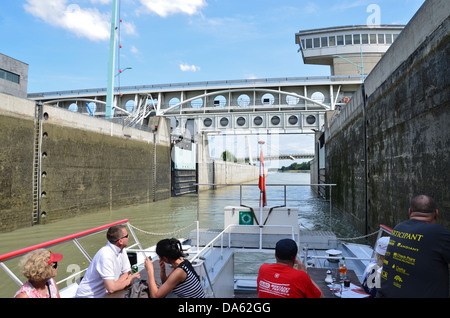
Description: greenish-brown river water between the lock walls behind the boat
0,173,361,298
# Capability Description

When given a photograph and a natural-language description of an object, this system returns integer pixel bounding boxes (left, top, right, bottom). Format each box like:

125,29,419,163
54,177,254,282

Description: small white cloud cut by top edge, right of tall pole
140,0,206,18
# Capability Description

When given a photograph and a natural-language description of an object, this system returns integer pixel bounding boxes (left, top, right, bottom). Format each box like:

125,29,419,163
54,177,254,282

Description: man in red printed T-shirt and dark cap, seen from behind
257,239,323,298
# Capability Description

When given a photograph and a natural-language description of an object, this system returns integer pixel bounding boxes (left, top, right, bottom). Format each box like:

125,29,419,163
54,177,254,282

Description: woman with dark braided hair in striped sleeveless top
145,238,205,298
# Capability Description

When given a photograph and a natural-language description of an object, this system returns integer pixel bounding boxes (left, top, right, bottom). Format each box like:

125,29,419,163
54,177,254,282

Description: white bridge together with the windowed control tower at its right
28,25,404,139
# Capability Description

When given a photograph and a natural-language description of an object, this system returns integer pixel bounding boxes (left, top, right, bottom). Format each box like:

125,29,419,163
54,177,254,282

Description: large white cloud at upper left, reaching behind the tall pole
24,0,135,41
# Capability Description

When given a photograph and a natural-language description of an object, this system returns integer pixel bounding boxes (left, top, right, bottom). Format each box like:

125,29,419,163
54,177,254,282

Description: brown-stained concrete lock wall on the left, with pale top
0,94,171,231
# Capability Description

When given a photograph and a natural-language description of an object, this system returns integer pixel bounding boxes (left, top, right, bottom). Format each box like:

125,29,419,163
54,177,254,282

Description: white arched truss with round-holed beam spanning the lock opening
165,88,331,134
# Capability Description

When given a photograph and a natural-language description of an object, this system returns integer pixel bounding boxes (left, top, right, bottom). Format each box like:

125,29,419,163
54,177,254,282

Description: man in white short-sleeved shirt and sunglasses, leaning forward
76,225,140,298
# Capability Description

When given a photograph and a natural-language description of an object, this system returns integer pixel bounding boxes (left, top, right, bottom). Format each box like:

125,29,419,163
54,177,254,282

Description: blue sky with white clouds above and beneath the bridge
0,0,424,165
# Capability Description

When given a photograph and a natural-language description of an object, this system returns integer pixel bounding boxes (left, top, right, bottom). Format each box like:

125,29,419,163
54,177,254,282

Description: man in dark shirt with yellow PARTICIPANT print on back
377,195,450,298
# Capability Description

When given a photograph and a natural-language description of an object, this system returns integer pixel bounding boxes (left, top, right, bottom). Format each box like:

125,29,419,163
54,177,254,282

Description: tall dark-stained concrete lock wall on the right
325,0,450,233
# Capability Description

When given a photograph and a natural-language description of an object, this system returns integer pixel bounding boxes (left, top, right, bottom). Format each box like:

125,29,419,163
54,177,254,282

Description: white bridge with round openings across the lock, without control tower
28,76,361,134
